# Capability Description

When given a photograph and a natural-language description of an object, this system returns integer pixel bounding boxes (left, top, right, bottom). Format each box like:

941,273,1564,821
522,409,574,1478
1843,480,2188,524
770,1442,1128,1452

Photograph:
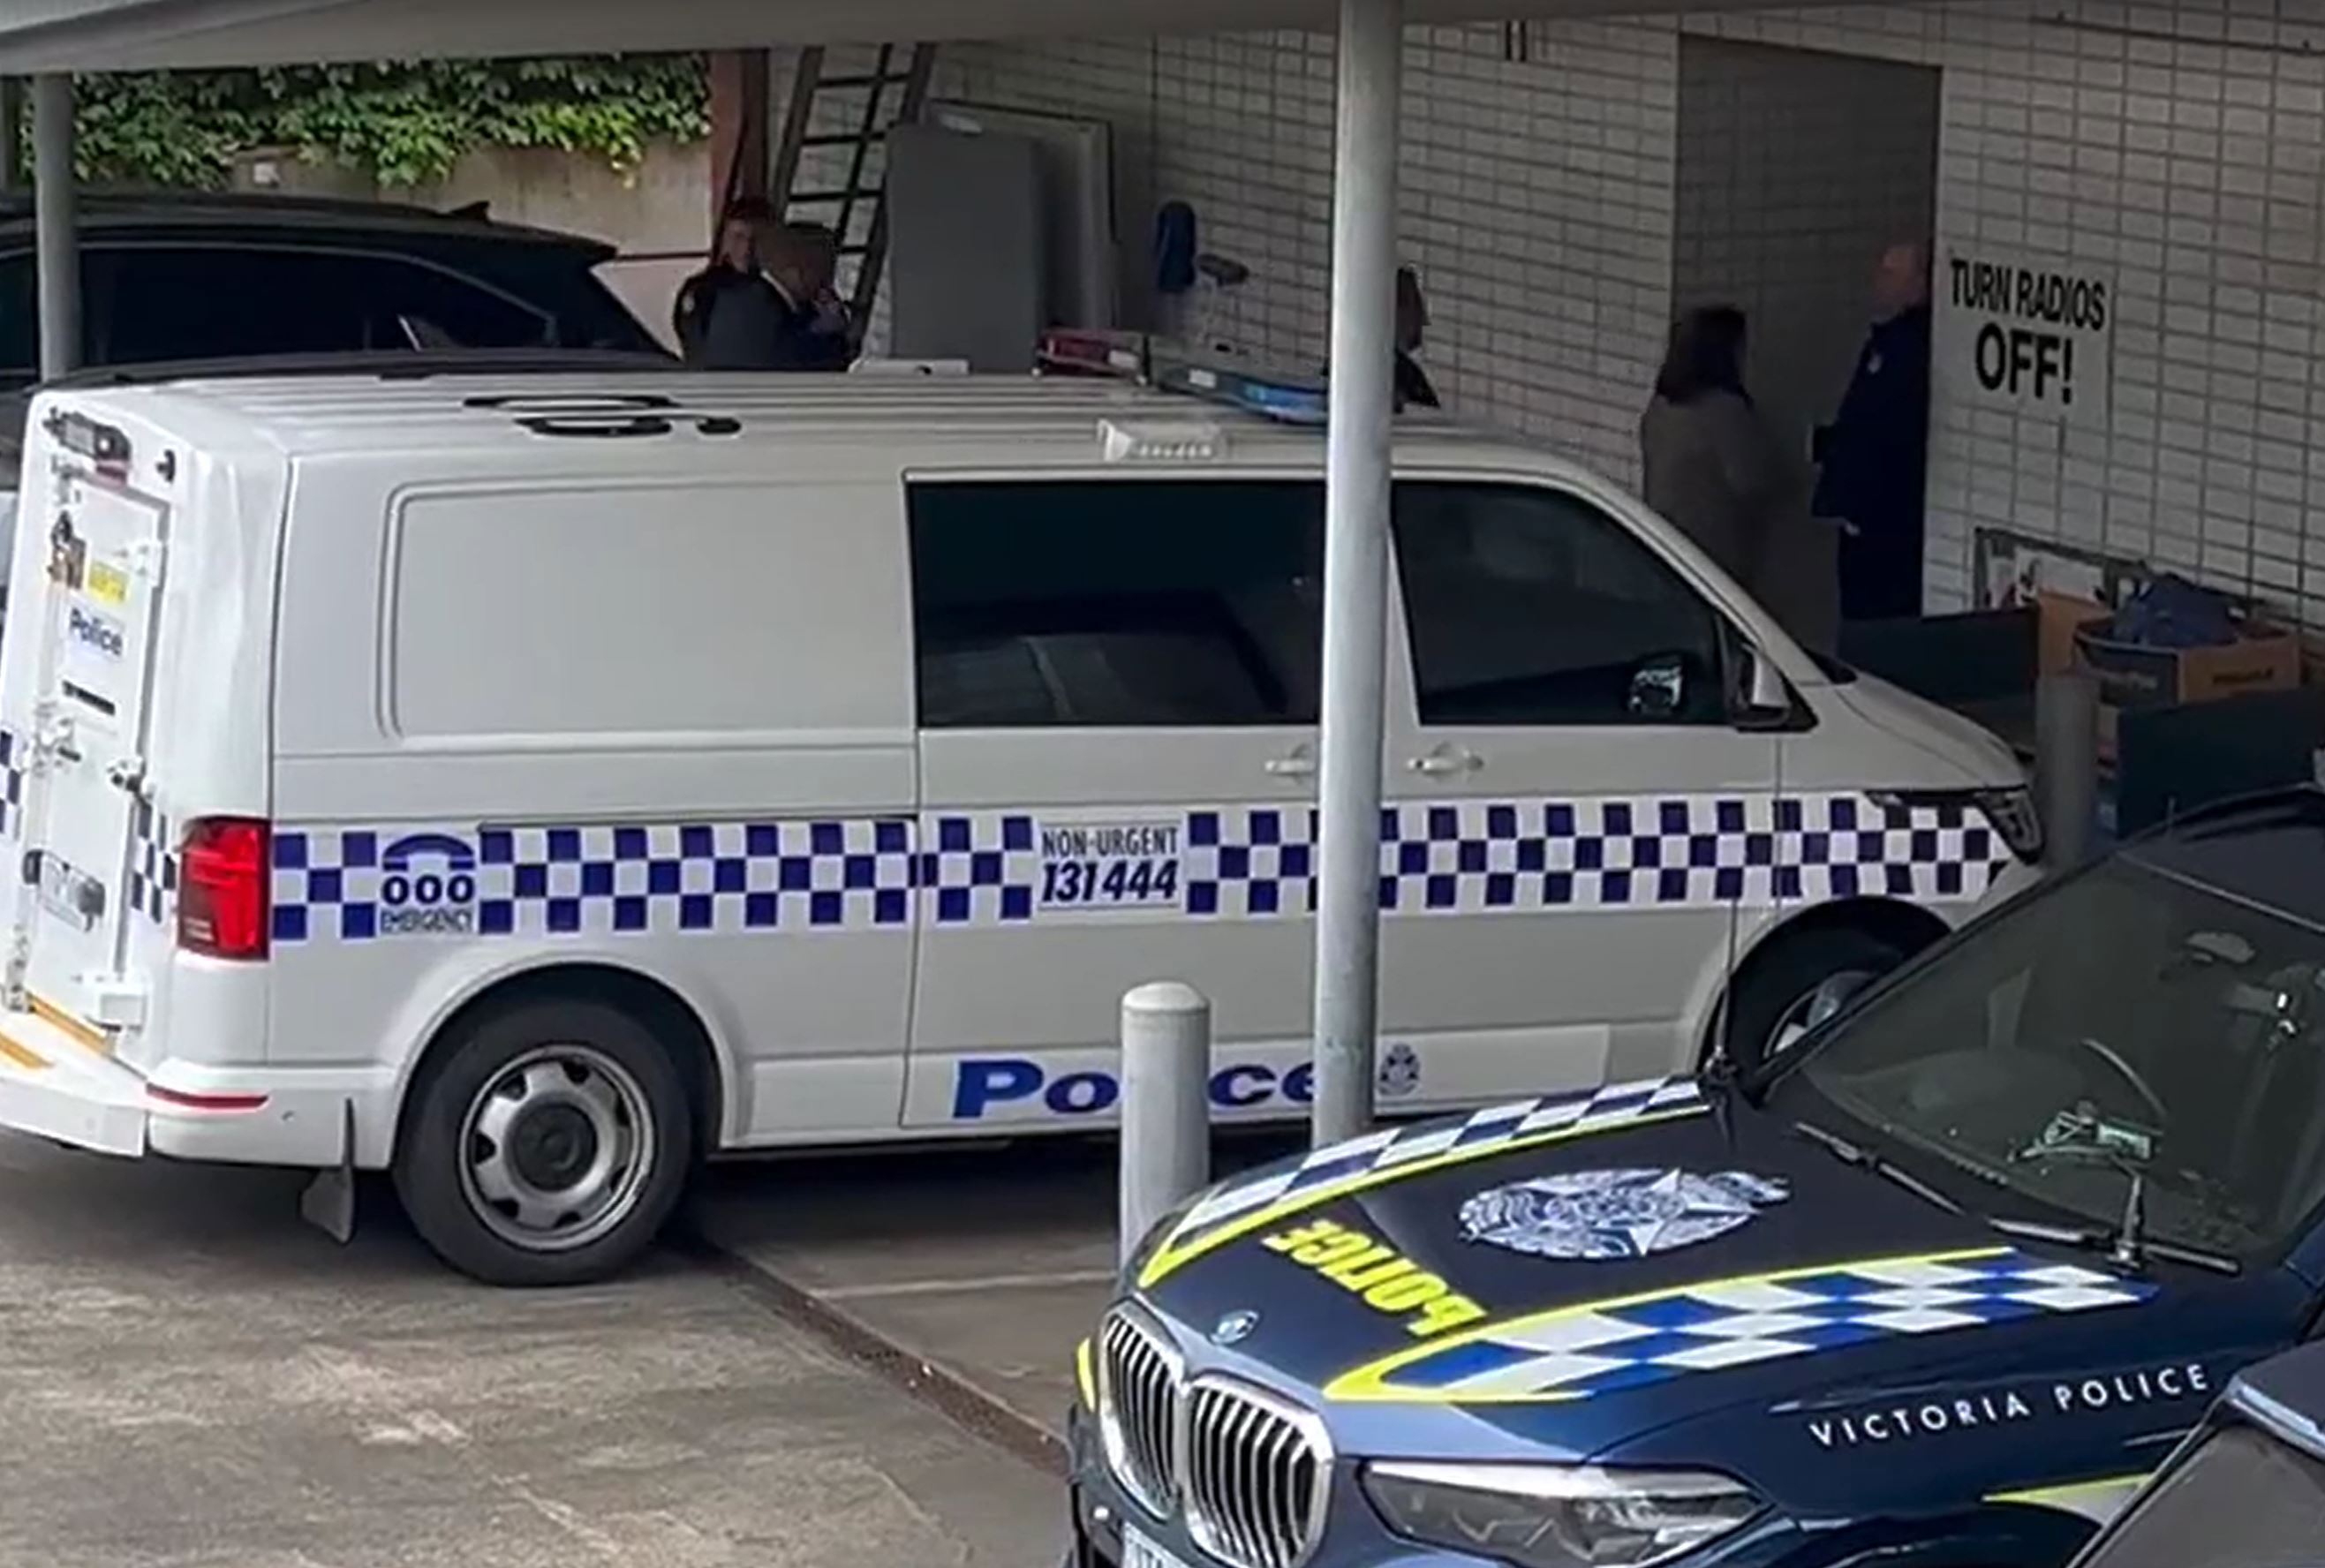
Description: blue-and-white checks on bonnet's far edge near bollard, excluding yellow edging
1172,1078,1704,1248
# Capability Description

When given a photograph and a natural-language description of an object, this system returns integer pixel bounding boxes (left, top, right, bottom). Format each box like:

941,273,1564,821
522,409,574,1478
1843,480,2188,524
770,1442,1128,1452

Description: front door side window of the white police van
1395,481,1727,725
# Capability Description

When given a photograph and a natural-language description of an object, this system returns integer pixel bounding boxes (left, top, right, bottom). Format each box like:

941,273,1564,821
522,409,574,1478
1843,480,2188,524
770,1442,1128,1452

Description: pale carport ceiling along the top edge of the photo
0,0,1774,74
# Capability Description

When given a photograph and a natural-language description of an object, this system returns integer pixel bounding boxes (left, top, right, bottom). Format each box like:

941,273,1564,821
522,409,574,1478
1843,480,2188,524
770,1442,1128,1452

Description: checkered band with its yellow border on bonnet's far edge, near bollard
1139,1078,1711,1289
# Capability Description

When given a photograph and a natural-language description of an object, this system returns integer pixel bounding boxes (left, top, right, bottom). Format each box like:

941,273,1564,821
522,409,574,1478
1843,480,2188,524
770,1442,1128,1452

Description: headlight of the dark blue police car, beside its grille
1365,1461,1760,1568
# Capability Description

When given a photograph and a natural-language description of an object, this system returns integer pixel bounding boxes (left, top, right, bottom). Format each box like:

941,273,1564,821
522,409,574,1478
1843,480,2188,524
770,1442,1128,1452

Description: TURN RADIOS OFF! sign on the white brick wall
1936,251,2116,413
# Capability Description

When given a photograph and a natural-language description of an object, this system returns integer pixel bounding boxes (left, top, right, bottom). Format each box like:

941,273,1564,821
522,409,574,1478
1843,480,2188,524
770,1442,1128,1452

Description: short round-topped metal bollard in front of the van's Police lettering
1121,980,1212,1262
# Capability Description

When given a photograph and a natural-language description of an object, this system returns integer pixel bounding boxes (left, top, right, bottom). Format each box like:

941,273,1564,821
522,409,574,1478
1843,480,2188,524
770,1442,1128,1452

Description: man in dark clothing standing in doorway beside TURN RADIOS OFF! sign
1814,244,1929,621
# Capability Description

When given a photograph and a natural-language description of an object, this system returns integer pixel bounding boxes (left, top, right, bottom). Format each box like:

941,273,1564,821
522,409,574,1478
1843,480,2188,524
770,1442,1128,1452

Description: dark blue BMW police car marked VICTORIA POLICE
1072,792,2325,1568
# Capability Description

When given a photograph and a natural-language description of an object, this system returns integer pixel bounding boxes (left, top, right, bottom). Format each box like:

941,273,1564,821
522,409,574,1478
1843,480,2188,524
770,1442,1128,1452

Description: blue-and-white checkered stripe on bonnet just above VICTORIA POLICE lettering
1358,1250,2155,1403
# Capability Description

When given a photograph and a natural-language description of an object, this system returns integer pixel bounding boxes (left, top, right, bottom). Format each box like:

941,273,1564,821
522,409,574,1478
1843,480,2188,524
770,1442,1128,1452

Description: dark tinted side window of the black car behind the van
91,246,551,365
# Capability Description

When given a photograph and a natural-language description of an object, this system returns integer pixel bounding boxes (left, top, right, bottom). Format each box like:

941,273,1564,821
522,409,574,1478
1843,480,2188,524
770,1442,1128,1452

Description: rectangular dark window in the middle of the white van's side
911,479,1323,729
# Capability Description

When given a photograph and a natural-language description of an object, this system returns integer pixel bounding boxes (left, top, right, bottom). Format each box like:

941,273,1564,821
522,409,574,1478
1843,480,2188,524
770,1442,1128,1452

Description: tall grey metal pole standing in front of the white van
1316,0,1404,1145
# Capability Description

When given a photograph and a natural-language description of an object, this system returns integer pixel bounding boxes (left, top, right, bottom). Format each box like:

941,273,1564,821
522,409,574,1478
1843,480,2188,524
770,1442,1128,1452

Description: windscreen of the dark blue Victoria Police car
1771,857,2325,1259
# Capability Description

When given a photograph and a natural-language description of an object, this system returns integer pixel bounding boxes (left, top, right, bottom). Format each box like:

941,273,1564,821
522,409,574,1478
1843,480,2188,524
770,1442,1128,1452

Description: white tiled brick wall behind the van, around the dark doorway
799,0,2325,625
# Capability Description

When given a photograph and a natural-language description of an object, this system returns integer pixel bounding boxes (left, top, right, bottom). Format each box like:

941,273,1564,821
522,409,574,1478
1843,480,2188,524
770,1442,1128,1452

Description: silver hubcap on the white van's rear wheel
460,1045,656,1252
